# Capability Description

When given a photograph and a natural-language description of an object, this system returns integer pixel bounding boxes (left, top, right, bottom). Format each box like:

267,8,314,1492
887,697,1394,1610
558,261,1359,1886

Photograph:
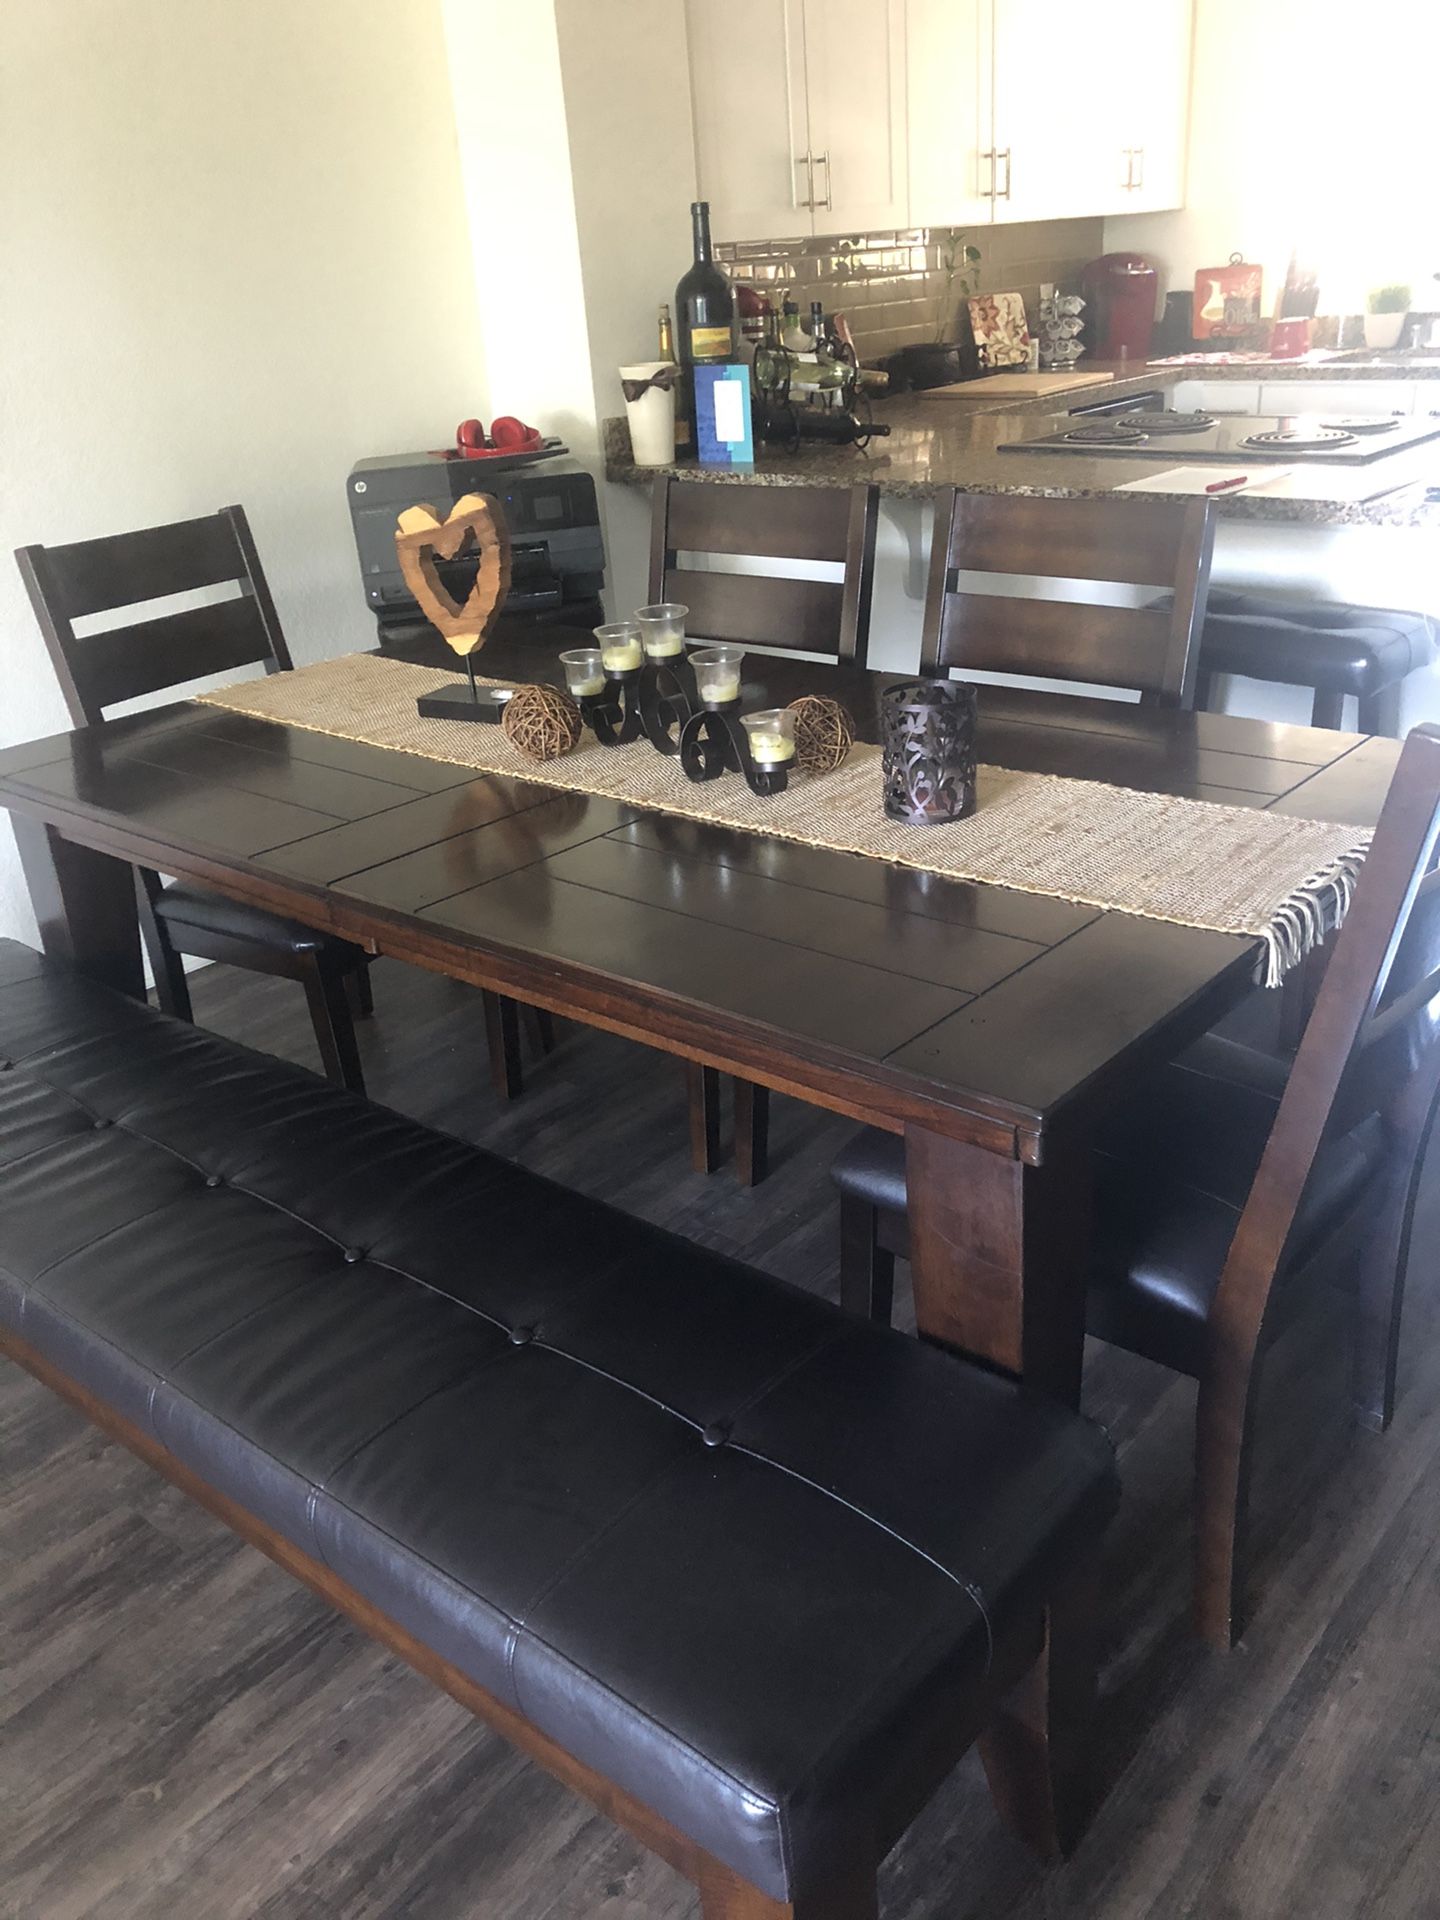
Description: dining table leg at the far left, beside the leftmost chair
12,814,146,1000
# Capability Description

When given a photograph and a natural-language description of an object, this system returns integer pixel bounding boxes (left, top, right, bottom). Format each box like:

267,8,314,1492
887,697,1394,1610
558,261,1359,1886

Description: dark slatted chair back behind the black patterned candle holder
920,488,1215,707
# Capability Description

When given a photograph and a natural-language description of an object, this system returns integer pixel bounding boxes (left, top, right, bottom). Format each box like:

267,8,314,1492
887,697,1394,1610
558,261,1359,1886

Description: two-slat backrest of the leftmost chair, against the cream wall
15,507,290,726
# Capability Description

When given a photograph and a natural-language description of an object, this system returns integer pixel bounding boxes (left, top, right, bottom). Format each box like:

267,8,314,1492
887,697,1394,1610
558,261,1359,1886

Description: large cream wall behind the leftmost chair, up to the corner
0,0,486,939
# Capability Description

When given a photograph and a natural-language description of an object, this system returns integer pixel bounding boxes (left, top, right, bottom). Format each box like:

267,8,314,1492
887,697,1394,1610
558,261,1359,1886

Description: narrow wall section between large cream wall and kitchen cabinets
444,0,695,614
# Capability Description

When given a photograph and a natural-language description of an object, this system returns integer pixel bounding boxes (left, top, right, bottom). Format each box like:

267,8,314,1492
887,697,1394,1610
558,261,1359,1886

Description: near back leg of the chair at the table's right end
1194,1359,1260,1653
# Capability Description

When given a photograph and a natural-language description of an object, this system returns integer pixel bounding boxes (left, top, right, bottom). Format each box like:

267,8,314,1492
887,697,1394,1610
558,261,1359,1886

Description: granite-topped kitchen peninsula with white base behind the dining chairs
605,355,1440,726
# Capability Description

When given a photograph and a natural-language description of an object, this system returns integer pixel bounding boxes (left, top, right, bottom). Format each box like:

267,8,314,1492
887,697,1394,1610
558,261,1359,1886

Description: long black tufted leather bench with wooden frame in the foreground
0,943,1116,1920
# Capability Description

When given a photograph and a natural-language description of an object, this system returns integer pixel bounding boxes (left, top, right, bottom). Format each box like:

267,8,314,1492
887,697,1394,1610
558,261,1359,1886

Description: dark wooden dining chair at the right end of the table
833,726,1440,1647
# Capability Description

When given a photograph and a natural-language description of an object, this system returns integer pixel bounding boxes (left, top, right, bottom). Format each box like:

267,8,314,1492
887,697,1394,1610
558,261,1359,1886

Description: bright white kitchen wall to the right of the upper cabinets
1106,0,1440,315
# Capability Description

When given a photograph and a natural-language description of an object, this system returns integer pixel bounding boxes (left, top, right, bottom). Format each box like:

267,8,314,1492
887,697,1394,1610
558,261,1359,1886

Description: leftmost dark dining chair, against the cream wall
15,507,372,1092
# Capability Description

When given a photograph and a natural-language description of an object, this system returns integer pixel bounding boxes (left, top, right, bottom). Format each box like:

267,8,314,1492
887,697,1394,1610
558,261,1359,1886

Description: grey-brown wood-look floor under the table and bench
0,964,1440,1920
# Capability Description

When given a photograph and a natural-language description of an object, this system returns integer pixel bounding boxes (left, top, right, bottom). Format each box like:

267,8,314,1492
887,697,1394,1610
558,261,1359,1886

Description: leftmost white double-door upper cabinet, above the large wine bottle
685,0,908,240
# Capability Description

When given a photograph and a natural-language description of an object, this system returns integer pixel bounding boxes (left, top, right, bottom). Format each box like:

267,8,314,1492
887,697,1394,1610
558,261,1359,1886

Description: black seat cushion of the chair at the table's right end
831,1035,1384,1373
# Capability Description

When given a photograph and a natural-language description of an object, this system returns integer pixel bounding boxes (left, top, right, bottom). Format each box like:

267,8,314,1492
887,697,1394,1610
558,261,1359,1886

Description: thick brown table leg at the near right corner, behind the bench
904,1127,1091,1405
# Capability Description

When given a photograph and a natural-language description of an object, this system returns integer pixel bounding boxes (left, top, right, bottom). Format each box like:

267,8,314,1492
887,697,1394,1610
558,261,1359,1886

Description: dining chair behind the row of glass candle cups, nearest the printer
649,476,879,1187
